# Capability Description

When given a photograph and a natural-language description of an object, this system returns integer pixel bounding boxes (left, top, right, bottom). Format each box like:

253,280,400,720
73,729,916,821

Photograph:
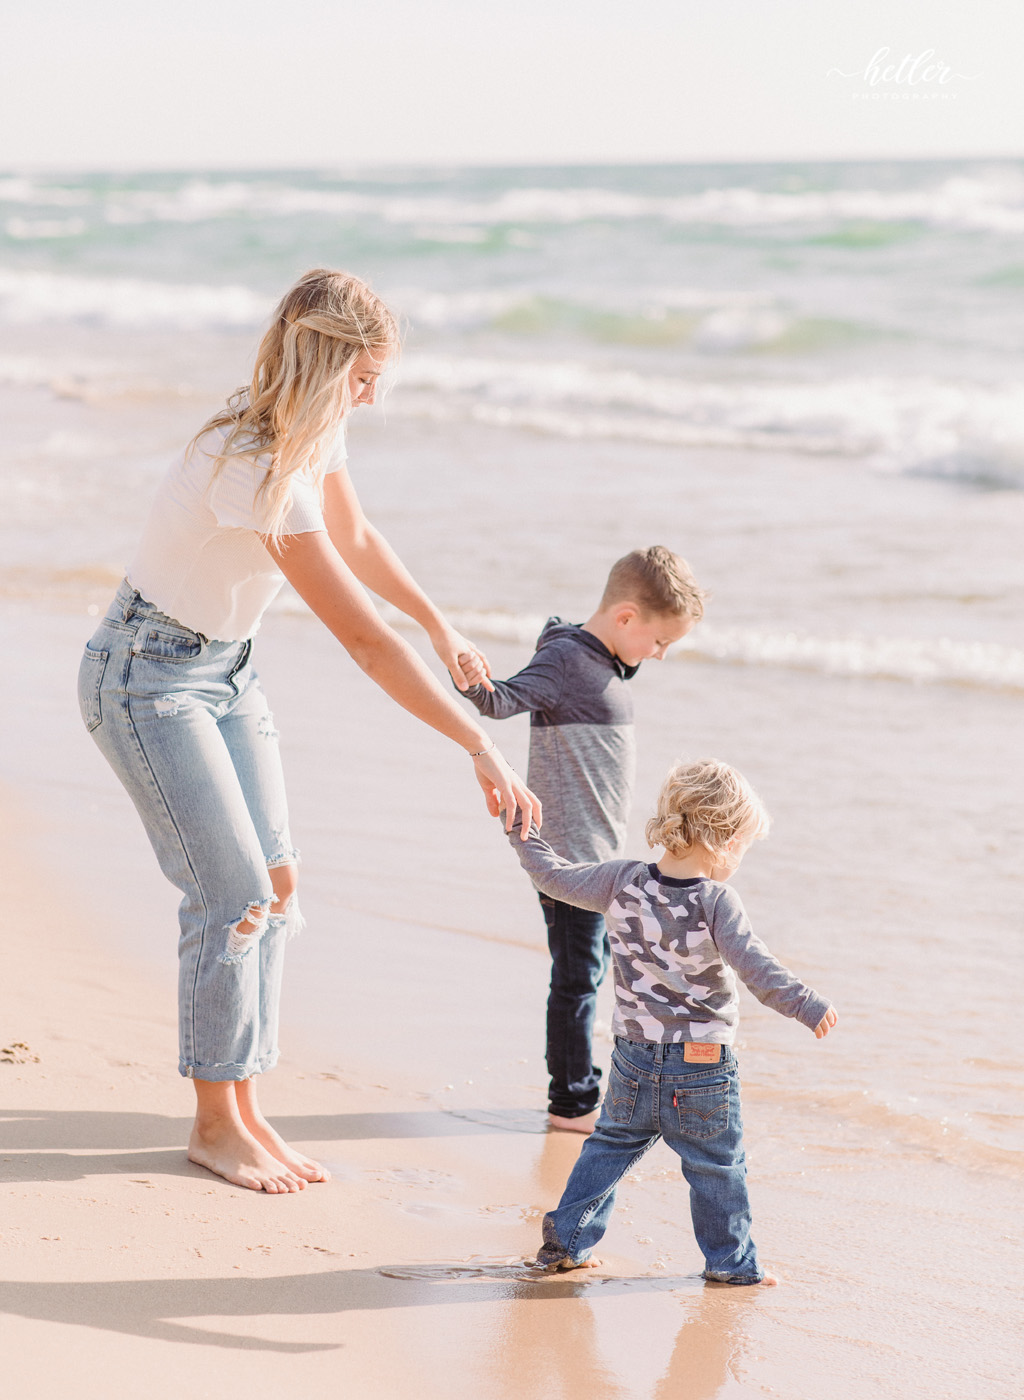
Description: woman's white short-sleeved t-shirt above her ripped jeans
127,428,347,641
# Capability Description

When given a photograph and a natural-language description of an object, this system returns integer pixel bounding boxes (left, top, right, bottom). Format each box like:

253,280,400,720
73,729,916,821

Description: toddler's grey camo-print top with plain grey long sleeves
510,822,829,1044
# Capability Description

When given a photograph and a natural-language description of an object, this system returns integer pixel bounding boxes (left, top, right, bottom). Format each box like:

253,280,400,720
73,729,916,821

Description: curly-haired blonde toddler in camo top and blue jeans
510,759,838,1284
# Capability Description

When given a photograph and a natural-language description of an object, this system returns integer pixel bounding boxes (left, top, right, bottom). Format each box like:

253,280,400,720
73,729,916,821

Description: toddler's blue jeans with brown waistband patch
537,1039,765,1284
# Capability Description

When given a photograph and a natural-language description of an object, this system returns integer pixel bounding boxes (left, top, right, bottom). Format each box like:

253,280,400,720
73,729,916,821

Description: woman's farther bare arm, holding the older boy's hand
324,468,492,690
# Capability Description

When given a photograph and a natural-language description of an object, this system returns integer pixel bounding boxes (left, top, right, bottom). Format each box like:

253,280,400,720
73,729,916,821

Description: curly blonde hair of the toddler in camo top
644,759,769,864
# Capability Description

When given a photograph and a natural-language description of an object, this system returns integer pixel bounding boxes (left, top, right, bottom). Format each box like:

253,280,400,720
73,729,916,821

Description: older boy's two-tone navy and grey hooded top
465,617,639,861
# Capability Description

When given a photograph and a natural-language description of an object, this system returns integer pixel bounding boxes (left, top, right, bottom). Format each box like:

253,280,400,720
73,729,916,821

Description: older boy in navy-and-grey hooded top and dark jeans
465,545,703,1133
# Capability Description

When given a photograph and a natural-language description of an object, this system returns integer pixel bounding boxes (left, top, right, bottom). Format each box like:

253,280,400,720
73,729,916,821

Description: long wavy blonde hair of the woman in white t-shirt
188,267,401,535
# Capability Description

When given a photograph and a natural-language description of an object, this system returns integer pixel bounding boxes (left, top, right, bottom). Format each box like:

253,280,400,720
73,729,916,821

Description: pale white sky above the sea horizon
0,0,1024,171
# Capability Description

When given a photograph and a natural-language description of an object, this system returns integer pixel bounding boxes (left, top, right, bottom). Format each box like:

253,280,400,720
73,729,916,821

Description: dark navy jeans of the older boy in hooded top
541,895,609,1119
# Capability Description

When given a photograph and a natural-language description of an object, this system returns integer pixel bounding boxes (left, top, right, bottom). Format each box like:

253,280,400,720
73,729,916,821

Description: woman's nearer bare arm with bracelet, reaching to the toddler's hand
263,531,541,840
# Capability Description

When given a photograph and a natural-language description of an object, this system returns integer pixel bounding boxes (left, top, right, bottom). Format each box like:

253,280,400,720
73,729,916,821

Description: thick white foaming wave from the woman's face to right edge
392,354,1024,487
